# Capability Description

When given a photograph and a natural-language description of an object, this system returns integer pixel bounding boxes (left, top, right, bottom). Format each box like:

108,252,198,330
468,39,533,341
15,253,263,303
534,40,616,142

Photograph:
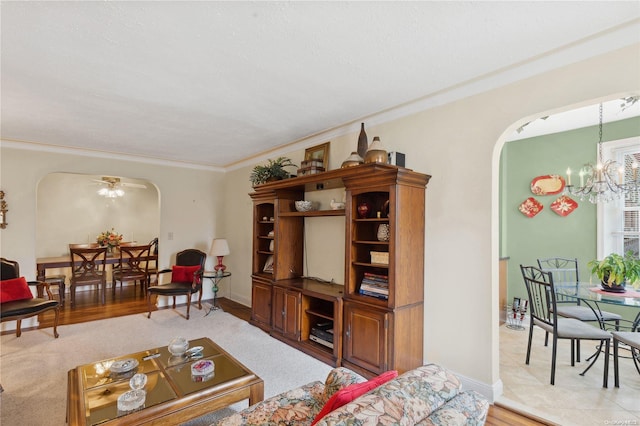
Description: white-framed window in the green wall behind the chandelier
598,137,640,259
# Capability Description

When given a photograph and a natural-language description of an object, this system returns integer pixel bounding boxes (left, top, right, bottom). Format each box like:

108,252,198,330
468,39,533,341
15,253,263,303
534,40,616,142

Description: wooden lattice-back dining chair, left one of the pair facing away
69,244,107,307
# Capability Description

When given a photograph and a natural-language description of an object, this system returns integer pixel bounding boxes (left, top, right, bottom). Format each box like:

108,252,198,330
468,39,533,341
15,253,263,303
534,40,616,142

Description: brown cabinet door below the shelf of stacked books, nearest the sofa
343,303,390,373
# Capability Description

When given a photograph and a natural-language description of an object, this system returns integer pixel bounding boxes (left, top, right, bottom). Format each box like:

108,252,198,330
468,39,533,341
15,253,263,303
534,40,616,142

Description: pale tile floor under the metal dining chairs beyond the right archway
498,325,640,426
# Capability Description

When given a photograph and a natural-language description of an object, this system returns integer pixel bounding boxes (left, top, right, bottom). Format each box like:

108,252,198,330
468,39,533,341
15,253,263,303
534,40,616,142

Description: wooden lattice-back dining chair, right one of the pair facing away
111,244,151,297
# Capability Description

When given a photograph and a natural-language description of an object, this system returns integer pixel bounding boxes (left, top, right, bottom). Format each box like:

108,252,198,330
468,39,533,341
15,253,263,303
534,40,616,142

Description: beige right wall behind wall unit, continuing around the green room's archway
225,44,640,395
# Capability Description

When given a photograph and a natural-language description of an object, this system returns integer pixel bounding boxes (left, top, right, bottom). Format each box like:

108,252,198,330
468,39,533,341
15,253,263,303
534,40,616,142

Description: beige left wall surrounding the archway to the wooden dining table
0,145,225,316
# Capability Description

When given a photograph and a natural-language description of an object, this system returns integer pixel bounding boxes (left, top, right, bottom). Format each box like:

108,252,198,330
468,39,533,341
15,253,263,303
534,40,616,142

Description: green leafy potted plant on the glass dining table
587,251,640,292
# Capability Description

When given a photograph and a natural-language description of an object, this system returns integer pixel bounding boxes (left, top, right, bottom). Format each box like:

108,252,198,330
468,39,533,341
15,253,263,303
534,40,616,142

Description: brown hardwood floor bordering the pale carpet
8,286,550,426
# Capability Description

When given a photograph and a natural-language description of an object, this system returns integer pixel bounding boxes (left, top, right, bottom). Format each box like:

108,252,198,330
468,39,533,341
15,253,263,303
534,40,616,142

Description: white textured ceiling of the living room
0,1,640,167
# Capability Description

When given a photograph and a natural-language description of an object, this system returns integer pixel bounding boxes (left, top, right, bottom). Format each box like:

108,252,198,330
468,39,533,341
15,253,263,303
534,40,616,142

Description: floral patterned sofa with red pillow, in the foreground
215,364,489,426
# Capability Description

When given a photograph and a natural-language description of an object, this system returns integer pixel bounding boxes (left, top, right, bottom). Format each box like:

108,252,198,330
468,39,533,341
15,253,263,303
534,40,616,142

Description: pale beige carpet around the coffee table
0,309,331,426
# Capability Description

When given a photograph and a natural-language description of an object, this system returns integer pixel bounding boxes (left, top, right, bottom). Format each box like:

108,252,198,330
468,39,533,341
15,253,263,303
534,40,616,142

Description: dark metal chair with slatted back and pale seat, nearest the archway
520,265,611,388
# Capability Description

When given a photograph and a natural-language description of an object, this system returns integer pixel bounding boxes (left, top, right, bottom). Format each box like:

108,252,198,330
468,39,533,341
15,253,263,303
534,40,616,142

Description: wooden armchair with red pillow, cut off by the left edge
0,258,60,339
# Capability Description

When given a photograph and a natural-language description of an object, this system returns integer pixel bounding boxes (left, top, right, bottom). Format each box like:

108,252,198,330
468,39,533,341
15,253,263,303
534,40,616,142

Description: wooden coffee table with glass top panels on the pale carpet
67,338,264,425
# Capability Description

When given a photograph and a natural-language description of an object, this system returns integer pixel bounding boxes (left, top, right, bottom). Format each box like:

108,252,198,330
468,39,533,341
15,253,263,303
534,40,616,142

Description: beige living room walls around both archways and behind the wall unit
0,44,640,396
